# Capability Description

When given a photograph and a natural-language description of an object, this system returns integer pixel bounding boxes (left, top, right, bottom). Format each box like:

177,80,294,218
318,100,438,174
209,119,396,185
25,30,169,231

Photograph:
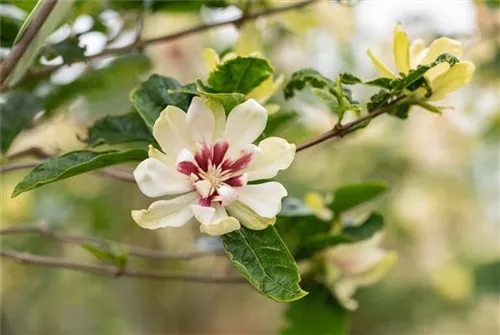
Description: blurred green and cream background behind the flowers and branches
0,0,500,335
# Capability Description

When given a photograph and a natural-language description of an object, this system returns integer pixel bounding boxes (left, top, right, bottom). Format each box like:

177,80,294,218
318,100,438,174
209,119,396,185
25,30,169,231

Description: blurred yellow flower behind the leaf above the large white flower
203,48,285,105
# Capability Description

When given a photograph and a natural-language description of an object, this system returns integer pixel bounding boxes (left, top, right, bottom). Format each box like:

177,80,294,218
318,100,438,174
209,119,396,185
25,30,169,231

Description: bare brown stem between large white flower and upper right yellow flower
296,96,405,152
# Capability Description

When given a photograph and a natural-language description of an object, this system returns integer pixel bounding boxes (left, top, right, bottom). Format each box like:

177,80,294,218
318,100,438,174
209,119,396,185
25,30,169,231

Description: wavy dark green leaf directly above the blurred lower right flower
296,212,384,259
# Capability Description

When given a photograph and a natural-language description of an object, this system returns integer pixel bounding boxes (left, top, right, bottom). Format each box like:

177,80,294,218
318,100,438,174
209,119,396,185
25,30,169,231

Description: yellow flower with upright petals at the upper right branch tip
367,23,475,101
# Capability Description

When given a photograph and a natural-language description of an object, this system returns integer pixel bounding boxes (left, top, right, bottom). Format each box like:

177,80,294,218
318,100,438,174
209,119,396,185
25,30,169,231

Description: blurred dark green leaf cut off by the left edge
0,91,42,152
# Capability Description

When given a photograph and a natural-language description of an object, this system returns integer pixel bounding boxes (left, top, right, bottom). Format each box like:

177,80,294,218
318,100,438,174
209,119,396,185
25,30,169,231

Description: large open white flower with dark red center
132,97,295,235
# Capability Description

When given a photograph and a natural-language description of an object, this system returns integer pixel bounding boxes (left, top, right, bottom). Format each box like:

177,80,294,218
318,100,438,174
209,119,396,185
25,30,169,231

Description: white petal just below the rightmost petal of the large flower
236,181,287,219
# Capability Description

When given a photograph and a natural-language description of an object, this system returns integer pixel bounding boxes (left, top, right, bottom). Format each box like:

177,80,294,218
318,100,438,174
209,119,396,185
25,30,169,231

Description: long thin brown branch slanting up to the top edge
10,0,318,87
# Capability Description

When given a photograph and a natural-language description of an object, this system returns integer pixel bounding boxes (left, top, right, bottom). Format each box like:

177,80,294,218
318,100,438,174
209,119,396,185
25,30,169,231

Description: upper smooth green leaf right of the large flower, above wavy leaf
330,181,389,214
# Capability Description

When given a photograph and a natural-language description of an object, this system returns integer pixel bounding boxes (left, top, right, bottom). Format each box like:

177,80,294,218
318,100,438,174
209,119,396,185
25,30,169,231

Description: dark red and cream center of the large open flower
177,141,252,207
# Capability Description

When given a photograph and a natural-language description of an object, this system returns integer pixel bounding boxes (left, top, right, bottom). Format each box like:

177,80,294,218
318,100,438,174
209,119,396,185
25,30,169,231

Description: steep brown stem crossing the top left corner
0,0,58,90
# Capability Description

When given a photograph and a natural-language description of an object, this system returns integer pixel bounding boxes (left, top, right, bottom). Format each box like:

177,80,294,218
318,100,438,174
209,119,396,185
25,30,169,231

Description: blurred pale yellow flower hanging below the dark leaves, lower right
325,233,397,310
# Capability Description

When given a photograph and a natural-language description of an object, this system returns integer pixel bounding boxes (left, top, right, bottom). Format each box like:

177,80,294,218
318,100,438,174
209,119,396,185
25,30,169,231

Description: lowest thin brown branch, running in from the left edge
0,250,246,284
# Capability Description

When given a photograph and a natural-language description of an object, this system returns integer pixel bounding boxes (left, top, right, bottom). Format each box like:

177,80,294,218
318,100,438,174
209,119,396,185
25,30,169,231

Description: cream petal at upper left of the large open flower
153,106,194,159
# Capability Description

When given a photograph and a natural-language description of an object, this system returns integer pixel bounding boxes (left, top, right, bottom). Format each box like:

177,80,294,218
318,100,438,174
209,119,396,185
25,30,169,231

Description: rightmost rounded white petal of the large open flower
245,137,295,181
